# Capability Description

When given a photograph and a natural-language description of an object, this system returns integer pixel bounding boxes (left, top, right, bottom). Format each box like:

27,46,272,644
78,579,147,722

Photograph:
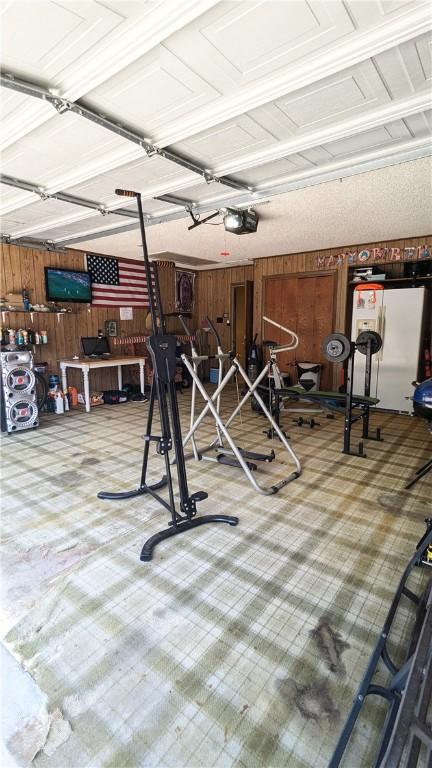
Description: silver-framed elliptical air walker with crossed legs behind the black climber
180,318,301,495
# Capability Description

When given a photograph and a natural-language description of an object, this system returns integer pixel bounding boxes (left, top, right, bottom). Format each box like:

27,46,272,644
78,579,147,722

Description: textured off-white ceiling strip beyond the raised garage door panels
78,158,432,268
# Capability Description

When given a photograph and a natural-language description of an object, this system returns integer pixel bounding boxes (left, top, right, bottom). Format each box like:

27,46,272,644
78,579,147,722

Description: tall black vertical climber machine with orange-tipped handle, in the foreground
98,189,238,560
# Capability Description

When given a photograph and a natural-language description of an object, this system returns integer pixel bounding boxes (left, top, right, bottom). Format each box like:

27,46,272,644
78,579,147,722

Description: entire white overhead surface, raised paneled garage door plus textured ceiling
0,0,431,268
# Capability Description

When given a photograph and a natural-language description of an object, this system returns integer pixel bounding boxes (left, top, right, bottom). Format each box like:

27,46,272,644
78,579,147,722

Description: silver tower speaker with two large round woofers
0,351,39,433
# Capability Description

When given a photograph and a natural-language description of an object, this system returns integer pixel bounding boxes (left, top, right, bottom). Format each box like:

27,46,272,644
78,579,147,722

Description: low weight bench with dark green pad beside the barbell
273,384,382,458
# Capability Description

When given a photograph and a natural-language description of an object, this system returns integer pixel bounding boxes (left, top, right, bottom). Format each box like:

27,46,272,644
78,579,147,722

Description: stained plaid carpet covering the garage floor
2,393,432,768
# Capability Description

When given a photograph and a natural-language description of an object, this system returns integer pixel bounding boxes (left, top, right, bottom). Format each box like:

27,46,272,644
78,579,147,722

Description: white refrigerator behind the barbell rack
351,286,425,413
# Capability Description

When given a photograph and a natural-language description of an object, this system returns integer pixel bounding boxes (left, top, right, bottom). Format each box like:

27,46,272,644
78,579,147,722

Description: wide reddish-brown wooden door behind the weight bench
263,272,336,389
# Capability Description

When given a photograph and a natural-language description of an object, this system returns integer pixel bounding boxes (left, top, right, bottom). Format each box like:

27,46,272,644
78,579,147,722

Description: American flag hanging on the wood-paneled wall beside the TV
87,253,153,307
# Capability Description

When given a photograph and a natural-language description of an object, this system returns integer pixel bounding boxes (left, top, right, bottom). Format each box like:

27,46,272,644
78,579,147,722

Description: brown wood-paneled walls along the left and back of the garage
0,235,432,389
